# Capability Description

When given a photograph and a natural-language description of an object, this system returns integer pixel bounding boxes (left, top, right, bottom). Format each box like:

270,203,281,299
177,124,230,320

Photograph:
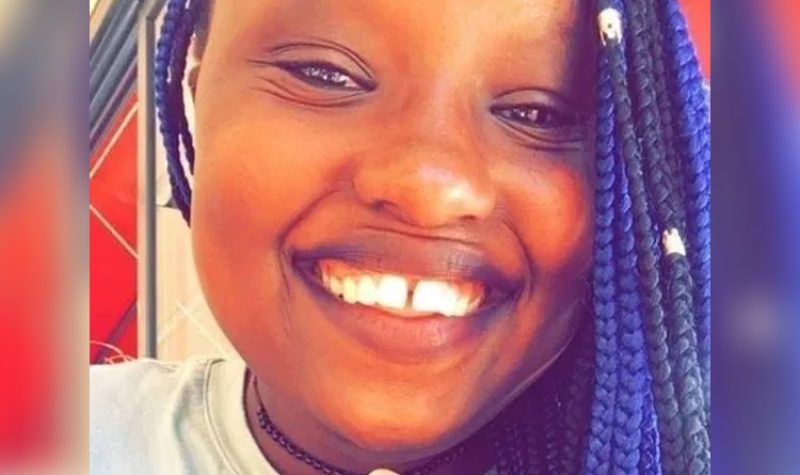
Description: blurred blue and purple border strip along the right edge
712,0,800,475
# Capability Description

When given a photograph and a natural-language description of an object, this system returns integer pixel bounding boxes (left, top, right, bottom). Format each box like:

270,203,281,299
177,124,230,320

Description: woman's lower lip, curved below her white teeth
295,269,512,362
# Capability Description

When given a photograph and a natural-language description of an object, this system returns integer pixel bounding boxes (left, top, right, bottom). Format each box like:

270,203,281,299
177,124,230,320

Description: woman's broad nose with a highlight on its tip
354,138,496,228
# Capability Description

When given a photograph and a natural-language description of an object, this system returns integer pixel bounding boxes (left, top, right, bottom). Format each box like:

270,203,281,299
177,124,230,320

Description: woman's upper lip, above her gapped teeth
292,230,519,296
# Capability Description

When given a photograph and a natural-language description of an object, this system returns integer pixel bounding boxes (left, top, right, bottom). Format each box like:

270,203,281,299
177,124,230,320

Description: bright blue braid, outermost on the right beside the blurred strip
661,0,711,417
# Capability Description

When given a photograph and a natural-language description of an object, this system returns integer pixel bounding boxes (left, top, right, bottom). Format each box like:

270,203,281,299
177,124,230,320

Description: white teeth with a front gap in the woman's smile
314,259,490,318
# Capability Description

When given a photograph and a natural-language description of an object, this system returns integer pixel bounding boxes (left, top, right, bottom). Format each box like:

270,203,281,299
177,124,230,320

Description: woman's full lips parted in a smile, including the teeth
291,233,521,359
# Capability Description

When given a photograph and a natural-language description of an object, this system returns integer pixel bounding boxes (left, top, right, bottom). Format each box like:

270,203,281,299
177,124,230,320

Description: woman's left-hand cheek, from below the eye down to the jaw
191,94,362,371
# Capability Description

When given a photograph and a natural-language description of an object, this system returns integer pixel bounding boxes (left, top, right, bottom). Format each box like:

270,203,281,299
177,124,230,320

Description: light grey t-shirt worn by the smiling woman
89,359,495,475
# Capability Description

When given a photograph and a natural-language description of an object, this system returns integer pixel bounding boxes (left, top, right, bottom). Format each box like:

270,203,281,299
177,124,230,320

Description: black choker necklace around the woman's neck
248,370,465,475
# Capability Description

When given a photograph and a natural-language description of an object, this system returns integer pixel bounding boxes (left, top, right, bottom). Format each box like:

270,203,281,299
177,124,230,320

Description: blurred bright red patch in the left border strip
0,124,64,464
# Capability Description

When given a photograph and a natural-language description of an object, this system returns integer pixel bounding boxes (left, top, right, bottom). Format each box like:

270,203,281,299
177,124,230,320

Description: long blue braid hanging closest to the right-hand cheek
586,45,618,474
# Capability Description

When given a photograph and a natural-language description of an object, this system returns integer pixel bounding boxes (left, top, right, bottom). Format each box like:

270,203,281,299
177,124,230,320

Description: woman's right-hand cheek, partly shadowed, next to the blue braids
478,160,593,397
